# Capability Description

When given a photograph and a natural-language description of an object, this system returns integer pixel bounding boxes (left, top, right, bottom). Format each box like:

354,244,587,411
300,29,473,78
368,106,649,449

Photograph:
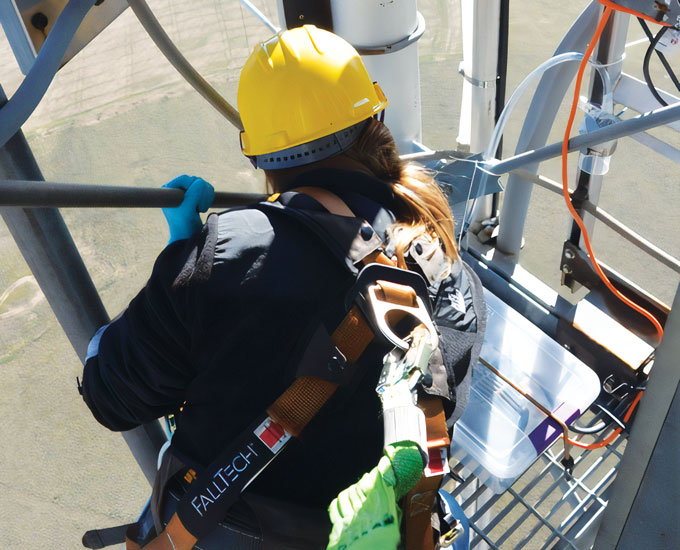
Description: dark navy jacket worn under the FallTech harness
83,169,483,508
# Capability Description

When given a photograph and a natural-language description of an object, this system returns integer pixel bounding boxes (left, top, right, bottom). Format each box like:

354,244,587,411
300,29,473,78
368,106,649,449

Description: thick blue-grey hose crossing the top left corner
0,0,95,147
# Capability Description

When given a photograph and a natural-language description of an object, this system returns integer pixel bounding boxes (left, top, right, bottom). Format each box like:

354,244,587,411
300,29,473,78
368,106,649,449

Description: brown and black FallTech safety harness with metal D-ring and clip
134,188,483,550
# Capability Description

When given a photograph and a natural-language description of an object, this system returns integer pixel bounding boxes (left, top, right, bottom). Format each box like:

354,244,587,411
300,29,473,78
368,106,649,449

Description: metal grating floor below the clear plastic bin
445,406,626,550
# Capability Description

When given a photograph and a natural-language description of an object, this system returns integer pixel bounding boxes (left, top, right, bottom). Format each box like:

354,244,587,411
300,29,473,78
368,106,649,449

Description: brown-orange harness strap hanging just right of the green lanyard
402,395,450,550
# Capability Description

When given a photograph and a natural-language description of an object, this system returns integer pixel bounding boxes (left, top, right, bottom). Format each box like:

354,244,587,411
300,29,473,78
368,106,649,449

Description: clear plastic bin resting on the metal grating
451,289,600,494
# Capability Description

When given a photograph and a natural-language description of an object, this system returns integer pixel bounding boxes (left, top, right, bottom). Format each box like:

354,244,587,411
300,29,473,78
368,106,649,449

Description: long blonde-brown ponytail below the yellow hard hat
344,119,459,267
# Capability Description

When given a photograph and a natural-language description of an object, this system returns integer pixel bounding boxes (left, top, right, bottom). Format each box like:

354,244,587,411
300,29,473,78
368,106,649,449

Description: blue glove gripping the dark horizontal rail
163,175,215,244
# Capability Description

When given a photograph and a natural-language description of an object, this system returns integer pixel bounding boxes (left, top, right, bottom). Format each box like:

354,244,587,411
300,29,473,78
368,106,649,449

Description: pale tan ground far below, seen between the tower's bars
0,0,680,550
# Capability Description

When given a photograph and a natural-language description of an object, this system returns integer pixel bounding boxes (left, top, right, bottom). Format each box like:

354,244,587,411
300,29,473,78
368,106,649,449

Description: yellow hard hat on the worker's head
238,25,387,169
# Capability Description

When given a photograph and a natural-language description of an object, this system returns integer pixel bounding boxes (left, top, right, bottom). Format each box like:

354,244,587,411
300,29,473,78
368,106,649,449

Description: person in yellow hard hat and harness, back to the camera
81,26,484,550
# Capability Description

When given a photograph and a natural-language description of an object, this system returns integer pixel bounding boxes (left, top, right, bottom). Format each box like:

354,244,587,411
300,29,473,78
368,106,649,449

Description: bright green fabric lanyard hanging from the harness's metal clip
327,441,424,550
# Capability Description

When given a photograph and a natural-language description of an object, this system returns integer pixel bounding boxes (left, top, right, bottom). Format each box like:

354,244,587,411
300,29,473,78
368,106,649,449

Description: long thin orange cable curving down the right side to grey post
562,5,663,341
